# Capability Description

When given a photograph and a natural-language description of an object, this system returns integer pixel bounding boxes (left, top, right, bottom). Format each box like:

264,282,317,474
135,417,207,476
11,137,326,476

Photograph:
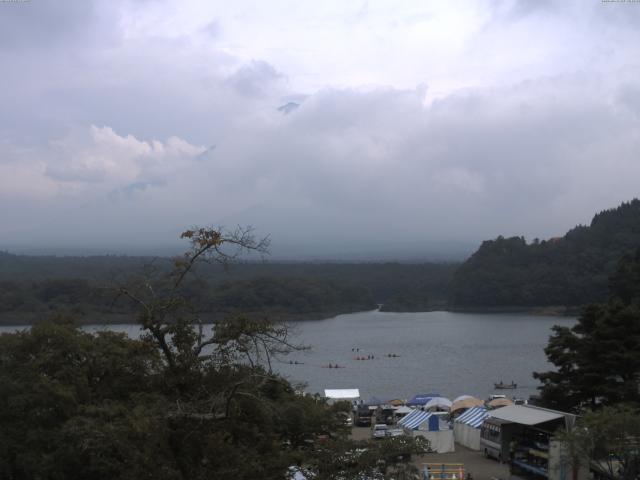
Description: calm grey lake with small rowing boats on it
0,311,575,400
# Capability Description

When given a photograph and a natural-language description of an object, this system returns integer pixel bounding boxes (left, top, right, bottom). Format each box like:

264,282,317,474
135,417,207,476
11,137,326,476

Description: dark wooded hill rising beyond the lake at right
449,199,640,308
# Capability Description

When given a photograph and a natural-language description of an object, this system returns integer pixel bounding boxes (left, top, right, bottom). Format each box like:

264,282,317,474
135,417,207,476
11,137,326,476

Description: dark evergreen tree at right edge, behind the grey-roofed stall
534,250,640,413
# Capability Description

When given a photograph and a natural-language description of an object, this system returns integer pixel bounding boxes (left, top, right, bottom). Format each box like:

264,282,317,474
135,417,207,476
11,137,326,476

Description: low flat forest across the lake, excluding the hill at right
0,253,456,324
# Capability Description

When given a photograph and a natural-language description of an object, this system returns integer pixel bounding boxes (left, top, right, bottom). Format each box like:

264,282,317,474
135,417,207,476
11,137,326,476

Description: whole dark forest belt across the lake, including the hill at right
0,199,640,324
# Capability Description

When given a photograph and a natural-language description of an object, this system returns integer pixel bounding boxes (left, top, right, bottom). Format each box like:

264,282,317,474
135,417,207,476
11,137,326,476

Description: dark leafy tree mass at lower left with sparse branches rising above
0,228,424,480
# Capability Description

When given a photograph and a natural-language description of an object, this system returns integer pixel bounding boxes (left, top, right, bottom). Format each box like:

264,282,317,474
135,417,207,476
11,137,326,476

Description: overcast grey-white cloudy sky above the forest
0,0,640,258
